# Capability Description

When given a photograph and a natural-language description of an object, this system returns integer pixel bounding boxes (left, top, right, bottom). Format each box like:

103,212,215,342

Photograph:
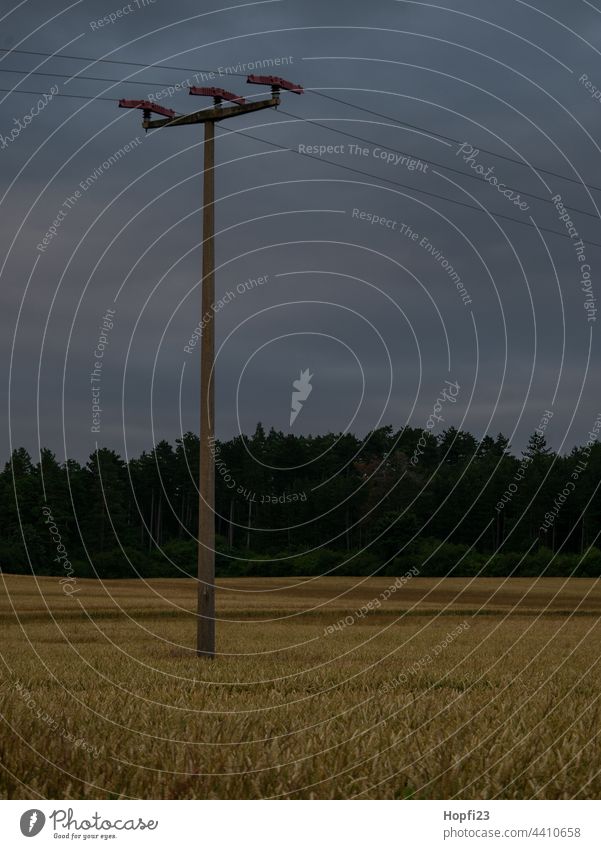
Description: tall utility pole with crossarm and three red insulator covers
119,74,303,659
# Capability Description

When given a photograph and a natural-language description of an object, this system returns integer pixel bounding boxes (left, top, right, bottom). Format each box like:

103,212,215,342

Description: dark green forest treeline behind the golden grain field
0,423,601,578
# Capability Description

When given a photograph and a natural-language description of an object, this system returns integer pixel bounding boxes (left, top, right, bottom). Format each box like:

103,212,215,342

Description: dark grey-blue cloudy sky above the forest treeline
0,0,601,458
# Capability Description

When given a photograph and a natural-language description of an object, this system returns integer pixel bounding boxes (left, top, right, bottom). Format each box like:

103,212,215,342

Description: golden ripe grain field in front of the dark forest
0,575,601,799
